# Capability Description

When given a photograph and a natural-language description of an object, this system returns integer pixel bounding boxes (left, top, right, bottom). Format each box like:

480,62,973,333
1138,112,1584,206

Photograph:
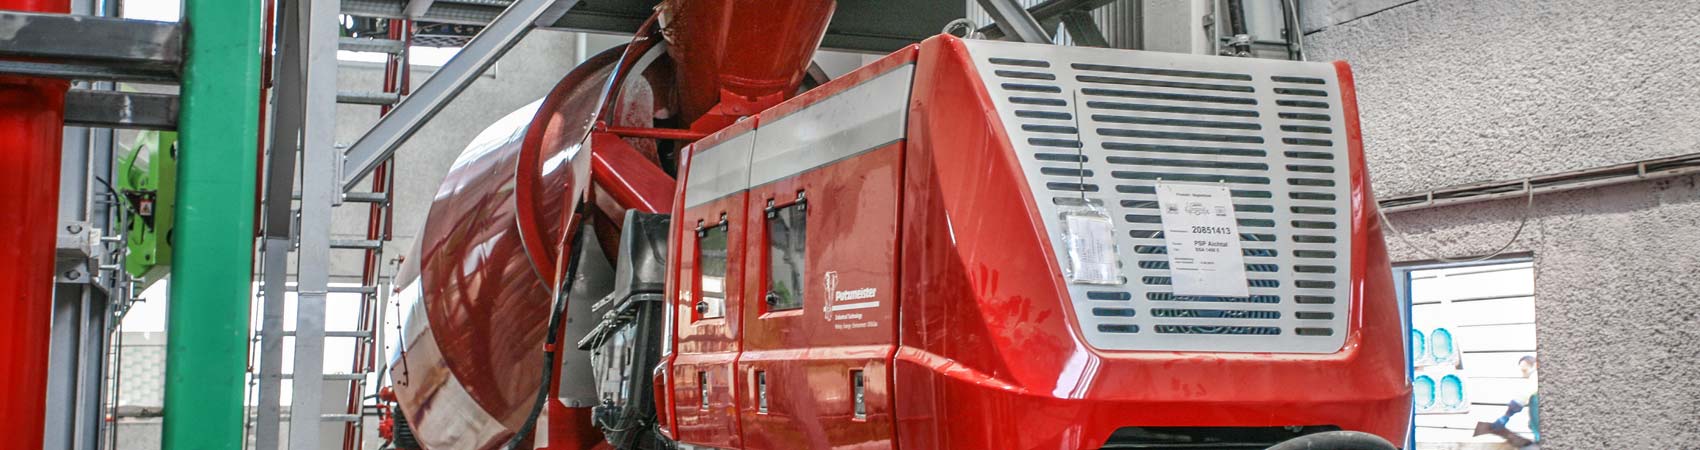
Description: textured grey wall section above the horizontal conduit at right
1306,0,1700,194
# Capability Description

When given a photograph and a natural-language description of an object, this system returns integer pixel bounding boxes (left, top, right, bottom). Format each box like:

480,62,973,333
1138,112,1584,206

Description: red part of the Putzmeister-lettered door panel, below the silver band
738,143,901,448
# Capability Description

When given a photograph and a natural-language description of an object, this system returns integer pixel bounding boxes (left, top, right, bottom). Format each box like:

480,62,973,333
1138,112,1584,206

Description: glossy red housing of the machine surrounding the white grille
656,37,1409,448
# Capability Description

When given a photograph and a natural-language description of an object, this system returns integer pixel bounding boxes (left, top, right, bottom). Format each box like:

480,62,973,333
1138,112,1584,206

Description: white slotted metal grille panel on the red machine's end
967,41,1352,353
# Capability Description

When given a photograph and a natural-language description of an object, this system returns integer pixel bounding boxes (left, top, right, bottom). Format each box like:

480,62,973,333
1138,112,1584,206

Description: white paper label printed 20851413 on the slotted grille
1158,183,1251,297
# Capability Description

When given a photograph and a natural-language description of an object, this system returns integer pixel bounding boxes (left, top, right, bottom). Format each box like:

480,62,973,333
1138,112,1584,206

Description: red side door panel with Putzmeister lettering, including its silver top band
738,65,913,448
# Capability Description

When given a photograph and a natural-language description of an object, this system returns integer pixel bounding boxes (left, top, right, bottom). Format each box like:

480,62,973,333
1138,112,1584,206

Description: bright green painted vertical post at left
163,0,260,450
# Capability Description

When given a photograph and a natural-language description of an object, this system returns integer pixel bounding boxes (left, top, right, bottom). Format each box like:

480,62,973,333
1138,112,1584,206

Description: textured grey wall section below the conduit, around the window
1380,172,1700,448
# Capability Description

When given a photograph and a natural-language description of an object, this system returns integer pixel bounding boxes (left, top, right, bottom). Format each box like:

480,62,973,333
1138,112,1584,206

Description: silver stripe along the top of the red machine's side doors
685,65,915,207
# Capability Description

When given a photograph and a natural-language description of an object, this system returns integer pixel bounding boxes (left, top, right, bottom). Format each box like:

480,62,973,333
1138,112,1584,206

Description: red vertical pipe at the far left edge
0,0,71,448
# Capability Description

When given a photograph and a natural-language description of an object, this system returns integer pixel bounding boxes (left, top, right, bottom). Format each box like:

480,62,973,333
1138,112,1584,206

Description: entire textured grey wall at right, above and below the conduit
1306,0,1700,450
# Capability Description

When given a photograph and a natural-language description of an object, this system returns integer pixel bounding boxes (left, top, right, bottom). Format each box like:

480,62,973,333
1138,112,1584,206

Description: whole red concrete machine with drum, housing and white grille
391,0,1411,450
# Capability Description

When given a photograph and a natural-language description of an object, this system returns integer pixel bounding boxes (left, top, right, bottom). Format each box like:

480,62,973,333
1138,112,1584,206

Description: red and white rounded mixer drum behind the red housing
389,49,621,448
